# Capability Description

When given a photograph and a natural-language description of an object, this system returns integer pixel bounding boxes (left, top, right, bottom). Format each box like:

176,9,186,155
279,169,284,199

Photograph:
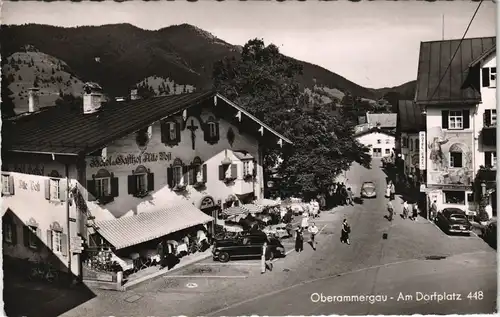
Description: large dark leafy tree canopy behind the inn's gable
213,39,371,196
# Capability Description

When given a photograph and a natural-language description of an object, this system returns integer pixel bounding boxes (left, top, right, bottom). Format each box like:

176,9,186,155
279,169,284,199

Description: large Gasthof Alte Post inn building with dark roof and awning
2,88,290,282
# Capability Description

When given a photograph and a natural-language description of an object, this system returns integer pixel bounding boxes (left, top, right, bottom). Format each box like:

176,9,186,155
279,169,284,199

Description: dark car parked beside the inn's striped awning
212,232,285,262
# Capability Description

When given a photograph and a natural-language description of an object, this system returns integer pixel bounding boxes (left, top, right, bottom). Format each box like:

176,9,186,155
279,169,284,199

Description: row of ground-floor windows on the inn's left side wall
2,215,68,256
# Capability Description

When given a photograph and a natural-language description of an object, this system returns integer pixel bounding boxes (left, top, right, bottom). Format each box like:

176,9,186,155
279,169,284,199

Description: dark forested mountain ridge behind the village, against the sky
0,24,377,105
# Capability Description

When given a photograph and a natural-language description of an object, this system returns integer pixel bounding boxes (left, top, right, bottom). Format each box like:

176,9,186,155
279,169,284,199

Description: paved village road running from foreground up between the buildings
60,162,497,316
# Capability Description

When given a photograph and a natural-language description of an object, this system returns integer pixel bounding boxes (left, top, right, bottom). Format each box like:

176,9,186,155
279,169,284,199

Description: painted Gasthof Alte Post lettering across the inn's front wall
88,152,172,168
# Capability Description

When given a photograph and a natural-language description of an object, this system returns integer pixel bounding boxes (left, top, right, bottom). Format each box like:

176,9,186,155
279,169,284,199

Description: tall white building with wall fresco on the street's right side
415,37,496,214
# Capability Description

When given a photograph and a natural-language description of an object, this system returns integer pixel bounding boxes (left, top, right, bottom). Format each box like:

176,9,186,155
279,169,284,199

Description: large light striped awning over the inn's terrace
97,203,214,250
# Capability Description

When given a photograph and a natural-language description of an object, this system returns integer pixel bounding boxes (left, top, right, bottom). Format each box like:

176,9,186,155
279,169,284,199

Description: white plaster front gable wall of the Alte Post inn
86,112,264,220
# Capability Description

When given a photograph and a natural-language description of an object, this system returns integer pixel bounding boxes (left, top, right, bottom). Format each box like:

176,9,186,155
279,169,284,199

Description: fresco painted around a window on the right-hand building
427,127,473,186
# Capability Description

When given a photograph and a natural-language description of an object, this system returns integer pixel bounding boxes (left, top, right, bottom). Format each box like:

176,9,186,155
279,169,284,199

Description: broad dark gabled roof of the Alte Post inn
2,91,292,155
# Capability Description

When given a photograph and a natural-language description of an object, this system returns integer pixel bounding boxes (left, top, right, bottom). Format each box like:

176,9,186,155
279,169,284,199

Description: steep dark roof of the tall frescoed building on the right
415,37,496,105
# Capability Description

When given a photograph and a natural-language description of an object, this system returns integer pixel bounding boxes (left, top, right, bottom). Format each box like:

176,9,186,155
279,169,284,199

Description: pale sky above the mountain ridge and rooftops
2,0,497,88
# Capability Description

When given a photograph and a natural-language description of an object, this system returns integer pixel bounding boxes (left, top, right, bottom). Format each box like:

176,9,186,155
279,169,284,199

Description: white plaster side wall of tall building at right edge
474,54,498,171
